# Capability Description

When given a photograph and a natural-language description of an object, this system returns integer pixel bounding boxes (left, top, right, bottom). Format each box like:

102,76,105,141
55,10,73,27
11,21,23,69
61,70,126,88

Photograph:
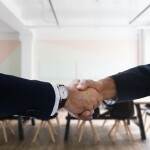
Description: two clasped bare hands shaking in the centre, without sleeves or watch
64,77,117,120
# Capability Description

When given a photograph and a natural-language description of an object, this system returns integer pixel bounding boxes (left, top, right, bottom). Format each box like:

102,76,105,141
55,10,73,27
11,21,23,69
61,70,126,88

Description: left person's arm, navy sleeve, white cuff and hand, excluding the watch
0,74,101,119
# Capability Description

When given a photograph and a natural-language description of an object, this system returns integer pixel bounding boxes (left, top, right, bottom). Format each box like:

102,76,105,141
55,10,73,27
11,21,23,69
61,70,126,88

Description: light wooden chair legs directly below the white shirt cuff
32,113,59,143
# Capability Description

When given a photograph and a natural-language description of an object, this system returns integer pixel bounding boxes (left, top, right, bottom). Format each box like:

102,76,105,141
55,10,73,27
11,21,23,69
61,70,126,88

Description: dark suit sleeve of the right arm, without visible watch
111,64,150,102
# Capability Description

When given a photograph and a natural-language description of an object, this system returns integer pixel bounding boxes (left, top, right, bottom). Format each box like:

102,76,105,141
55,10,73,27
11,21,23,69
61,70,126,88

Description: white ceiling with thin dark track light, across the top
0,0,150,32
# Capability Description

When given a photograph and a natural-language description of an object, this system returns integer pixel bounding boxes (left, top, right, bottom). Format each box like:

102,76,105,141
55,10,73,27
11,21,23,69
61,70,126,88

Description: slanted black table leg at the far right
135,104,146,140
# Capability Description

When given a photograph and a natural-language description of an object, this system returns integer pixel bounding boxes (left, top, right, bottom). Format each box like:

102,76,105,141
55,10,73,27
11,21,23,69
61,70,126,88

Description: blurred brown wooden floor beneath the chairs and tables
0,109,150,150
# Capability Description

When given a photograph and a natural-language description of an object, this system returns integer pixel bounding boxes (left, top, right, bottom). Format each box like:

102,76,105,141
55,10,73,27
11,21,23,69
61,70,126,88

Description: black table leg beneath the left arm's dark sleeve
18,116,24,141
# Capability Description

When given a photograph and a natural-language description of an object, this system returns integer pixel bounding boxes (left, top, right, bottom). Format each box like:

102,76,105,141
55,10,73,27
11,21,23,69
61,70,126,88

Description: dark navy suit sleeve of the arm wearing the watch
0,74,55,119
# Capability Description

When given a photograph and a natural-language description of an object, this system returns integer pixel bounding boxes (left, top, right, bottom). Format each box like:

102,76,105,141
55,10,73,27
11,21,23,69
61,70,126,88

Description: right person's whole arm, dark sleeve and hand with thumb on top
77,65,150,101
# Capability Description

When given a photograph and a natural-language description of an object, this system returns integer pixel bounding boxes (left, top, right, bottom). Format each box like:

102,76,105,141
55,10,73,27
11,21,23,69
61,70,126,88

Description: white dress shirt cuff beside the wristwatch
50,85,60,116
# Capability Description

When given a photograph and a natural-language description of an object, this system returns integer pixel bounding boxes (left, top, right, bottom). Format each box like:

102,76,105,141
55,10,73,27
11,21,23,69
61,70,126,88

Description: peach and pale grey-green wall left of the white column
0,40,21,76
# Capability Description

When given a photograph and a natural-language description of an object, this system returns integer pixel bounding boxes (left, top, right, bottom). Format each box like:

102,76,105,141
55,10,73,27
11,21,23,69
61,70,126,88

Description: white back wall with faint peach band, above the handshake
35,28,138,83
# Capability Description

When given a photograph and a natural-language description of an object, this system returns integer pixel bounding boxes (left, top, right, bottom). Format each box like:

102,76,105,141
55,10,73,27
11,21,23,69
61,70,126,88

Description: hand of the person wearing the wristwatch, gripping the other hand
64,81,102,119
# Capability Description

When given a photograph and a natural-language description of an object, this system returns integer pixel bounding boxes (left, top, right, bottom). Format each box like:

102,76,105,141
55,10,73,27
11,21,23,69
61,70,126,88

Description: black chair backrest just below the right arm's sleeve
110,101,134,119
